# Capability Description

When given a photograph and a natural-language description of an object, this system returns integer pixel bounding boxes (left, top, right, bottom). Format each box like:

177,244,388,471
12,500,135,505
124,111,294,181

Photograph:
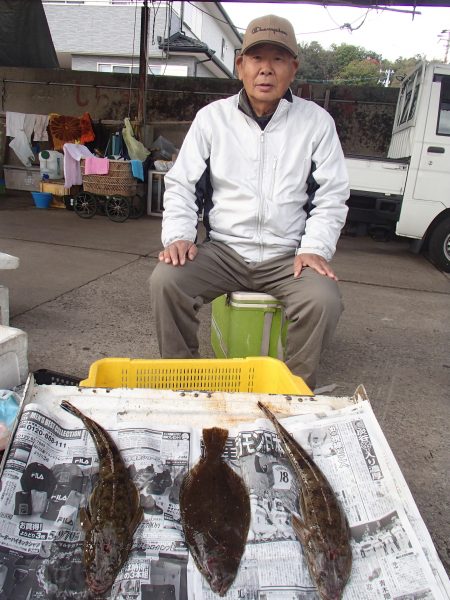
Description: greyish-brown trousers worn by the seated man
150,241,343,389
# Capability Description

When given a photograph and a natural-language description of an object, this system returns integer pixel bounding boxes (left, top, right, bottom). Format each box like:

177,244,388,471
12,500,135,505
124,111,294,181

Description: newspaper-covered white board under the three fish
0,386,450,600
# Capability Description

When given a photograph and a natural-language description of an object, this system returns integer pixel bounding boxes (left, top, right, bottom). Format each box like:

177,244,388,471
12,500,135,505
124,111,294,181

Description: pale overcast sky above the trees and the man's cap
223,2,450,62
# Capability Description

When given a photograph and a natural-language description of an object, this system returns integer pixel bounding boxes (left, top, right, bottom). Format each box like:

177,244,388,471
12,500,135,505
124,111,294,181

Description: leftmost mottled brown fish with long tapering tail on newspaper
61,400,143,594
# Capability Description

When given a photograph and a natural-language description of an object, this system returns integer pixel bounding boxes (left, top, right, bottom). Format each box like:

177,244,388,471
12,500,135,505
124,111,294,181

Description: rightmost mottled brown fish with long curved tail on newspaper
258,402,352,600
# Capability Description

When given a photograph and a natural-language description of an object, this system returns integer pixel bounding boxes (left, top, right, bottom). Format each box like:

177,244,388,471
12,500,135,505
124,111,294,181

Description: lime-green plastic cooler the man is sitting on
211,292,287,360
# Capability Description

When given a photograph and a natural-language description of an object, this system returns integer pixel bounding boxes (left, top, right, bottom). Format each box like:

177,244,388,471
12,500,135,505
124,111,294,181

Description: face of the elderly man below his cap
236,44,298,116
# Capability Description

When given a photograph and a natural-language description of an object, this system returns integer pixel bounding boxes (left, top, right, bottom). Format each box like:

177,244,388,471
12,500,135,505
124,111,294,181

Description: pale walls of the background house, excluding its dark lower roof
43,0,236,77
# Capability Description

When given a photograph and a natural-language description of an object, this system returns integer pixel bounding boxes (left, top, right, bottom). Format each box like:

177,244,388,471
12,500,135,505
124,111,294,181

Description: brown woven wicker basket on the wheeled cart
80,159,137,197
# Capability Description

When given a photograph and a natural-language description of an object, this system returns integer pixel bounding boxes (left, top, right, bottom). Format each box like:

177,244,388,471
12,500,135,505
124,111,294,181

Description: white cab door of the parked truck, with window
412,73,450,206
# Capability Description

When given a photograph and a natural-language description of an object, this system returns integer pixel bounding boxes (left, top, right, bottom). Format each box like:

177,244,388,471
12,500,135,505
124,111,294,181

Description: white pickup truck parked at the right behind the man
346,63,450,273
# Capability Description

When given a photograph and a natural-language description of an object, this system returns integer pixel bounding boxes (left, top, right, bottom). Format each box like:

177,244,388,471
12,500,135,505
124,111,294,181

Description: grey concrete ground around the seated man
0,192,450,573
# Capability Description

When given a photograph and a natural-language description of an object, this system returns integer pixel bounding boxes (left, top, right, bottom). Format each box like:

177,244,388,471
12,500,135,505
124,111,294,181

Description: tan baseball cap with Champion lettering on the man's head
241,15,298,57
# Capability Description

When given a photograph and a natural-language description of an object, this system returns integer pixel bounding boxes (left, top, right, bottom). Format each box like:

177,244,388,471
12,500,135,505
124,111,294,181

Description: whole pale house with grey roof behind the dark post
43,0,242,78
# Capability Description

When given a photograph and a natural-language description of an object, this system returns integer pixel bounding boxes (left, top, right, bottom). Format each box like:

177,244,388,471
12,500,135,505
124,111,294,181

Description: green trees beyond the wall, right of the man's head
297,42,422,87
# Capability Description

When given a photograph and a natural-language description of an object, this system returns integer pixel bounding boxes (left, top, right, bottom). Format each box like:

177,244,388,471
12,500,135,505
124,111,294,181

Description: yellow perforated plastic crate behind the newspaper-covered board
80,356,313,396
